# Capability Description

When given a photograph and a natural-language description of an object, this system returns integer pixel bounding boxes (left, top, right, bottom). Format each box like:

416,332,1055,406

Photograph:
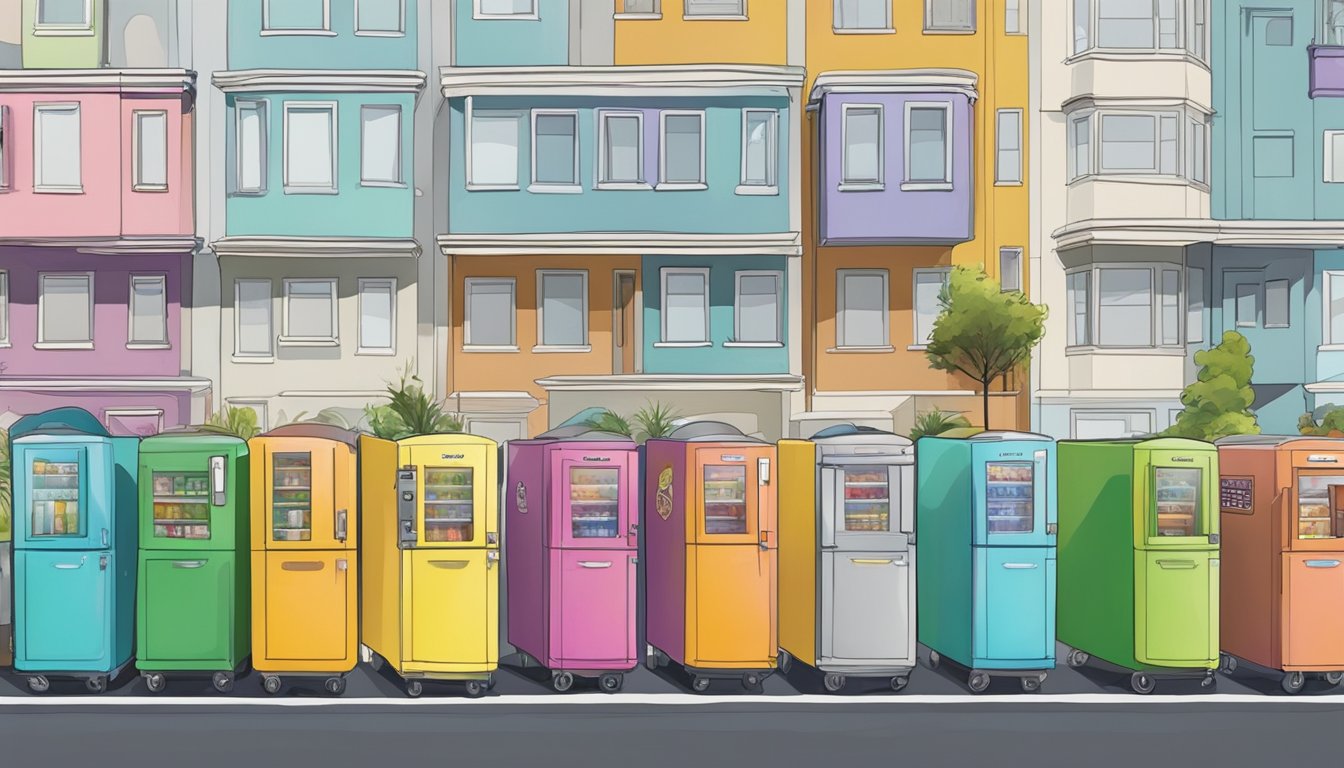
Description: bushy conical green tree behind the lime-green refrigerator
1163,331,1259,441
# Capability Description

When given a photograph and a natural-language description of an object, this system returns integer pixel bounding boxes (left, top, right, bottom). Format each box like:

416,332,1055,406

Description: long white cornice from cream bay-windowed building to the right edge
1051,219,1344,250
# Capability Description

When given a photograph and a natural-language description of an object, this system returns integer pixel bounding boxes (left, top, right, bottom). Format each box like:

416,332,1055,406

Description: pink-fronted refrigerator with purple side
504,425,638,693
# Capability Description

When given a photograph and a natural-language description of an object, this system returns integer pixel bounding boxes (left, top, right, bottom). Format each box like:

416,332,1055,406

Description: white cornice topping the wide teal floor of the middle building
438,65,804,98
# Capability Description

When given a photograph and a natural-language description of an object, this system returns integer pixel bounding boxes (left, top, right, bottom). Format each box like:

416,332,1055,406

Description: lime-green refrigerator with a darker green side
1056,437,1219,694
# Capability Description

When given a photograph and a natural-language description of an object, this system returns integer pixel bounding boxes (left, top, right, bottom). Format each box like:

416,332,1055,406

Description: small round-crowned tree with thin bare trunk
925,266,1046,429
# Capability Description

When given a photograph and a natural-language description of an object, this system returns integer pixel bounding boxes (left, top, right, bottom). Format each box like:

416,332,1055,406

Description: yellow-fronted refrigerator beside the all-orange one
359,434,500,697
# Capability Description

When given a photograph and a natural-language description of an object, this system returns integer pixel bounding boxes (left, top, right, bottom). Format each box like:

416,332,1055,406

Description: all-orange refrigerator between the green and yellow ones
247,424,359,695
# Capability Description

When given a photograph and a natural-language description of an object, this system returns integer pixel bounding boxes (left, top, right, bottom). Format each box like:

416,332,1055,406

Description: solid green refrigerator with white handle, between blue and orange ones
136,430,251,693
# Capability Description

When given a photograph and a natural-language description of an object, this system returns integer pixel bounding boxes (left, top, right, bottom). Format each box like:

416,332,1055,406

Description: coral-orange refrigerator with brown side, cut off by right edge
1218,436,1344,694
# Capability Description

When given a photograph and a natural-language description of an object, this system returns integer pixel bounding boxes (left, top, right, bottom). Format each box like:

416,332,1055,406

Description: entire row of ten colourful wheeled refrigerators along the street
5,409,1344,695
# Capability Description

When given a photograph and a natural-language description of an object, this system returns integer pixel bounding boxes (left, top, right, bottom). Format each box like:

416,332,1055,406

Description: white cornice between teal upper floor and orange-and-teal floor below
438,231,802,256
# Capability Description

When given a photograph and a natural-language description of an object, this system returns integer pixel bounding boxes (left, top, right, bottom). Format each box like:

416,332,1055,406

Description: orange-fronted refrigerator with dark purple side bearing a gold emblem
644,421,780,693
